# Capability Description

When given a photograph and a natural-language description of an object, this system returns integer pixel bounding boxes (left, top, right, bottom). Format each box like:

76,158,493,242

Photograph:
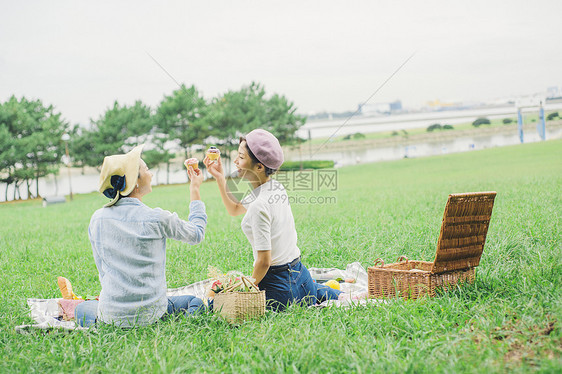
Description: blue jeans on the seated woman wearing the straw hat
74,295,204,327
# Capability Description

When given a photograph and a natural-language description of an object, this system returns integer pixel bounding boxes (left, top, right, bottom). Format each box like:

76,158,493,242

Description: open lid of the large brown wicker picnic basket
431,192,496,273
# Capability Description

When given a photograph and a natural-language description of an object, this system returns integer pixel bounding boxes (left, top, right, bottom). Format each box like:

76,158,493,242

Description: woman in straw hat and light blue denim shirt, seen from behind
75,145,207,327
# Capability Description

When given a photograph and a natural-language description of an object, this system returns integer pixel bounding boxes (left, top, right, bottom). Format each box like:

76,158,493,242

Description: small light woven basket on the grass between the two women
213,276,265,323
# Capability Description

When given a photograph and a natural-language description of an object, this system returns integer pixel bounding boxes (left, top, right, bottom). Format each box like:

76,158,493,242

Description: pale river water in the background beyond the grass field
0,103,562,201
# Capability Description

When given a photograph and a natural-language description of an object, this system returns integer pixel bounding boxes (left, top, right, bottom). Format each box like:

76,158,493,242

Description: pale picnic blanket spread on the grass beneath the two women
16,262,381,332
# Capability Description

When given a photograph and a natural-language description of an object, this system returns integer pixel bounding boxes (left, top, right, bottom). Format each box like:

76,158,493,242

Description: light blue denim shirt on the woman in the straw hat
88,197,203,327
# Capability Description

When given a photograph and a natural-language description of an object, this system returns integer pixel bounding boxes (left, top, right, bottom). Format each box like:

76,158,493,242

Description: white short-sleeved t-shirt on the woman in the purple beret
242,179,301,266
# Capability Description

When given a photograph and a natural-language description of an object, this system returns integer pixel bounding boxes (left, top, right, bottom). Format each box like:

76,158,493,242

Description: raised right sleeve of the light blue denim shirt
156,200,207,245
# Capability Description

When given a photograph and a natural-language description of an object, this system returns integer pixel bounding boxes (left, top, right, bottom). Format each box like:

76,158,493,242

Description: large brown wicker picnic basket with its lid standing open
367,192,496,299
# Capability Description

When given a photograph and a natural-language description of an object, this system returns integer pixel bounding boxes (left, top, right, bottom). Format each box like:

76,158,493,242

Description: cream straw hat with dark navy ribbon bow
99,144,144,207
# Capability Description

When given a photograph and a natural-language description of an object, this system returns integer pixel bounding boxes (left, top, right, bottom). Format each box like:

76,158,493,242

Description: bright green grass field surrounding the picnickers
0,141,562,373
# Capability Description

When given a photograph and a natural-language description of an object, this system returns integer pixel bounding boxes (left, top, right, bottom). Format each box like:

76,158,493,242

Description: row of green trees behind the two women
0,82,306,201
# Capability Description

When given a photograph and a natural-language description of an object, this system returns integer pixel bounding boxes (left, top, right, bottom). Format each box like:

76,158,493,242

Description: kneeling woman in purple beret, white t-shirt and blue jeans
203,129,340,310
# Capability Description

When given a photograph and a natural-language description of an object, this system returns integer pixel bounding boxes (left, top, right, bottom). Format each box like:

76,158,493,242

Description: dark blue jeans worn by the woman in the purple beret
258,260,341,311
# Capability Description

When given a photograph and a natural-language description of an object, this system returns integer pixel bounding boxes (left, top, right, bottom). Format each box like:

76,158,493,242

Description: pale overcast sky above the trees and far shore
0,0,562,123
